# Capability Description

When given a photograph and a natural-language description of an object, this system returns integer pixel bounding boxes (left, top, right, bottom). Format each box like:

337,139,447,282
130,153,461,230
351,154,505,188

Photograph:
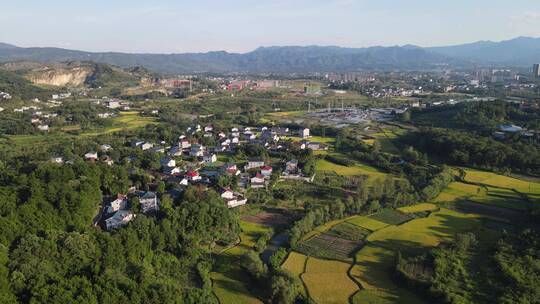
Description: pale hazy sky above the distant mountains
0,0,540,53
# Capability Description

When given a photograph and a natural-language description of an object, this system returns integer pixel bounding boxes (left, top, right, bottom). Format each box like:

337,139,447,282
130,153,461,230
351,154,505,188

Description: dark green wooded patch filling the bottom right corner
396,230,540,304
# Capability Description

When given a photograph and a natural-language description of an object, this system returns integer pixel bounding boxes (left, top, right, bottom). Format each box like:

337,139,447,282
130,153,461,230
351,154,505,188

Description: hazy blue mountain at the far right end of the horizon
427,37,540,66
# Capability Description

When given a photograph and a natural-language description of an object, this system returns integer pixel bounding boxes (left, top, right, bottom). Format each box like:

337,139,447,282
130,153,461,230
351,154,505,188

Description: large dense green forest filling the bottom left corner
0,162,239,303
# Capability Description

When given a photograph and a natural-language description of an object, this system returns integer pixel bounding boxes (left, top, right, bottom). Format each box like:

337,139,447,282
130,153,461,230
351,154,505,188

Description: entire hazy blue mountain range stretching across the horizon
0,37,540,74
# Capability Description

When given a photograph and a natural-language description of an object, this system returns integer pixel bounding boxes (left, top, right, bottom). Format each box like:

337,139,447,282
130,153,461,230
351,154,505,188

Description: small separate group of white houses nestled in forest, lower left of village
102,189,159,230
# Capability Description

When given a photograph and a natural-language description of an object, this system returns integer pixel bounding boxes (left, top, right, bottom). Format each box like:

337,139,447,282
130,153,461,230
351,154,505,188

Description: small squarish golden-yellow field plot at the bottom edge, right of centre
301,258,358,303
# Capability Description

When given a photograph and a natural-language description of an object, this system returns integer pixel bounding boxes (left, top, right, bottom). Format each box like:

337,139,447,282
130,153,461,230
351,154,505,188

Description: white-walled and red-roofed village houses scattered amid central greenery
70,126,325,230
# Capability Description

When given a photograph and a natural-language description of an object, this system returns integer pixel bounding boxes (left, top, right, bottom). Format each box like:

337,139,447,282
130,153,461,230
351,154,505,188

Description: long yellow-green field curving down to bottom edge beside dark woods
351,209,482,303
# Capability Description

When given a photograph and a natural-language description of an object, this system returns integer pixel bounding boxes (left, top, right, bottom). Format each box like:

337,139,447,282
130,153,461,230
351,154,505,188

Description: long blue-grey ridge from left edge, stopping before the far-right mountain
0,44,457,74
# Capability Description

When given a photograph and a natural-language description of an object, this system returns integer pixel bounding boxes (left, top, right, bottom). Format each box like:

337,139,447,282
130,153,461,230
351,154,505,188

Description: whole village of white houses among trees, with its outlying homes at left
64,124,320,230
